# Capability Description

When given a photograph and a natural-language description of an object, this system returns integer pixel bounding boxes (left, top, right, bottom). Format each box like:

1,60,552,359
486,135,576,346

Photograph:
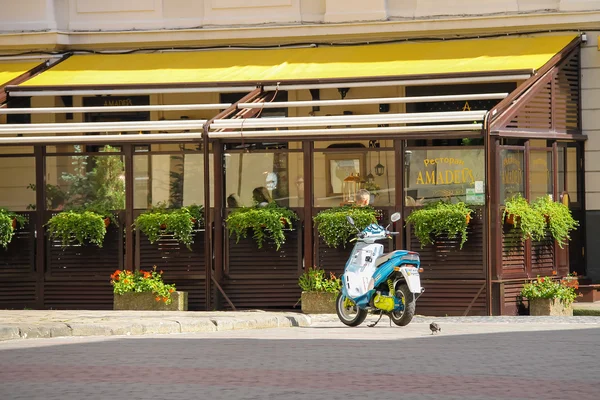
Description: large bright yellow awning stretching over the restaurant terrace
22,35,576,86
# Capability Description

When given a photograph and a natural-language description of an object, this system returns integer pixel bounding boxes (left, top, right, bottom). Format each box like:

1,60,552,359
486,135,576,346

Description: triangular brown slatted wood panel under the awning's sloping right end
506,82,552,131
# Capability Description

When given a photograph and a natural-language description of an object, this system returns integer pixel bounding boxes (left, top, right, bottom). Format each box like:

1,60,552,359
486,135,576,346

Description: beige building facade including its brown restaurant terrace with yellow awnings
0,0,600,315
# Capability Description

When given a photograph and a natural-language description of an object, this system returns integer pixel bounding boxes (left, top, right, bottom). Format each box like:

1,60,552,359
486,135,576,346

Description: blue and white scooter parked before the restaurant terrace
336,213,425,326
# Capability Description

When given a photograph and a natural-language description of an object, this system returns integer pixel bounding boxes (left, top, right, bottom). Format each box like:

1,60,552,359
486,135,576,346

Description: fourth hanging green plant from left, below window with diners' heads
225,202,298,250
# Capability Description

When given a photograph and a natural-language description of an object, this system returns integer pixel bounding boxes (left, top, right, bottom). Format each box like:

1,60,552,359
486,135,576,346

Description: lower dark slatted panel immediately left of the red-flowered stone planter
44,282,113,310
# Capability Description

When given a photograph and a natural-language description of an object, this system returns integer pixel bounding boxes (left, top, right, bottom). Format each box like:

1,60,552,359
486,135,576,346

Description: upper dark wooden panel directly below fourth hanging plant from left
227,229,302,277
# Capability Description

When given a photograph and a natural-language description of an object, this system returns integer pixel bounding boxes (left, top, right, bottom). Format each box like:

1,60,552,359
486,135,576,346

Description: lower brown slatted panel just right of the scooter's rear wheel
416,280,487,317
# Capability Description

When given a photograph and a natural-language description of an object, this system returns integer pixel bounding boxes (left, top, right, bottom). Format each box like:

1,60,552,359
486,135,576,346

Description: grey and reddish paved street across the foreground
0,318,600,400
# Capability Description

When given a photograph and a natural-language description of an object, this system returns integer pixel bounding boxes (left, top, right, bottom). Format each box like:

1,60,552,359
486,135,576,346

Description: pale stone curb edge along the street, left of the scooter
0,314,311,341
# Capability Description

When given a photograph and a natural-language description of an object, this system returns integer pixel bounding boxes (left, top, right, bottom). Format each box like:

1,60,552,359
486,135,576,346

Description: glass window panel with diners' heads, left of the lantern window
224,152,304,208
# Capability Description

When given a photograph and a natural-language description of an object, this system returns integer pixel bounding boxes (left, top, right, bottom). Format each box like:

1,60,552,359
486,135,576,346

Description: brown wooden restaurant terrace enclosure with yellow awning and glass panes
0,35,586,315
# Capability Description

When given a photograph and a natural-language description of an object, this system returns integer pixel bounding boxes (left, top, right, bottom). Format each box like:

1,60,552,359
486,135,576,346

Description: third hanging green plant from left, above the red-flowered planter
133,205,204,248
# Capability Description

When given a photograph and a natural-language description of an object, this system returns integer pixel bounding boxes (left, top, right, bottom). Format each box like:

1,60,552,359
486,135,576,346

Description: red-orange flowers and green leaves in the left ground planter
110,266,175,304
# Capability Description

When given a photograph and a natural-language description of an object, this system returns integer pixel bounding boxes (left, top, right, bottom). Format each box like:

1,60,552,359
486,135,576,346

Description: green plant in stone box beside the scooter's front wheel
298,267,342,314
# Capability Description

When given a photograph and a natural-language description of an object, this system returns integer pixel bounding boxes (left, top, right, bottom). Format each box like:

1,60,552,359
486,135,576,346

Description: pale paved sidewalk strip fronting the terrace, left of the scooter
0,310,310,341
